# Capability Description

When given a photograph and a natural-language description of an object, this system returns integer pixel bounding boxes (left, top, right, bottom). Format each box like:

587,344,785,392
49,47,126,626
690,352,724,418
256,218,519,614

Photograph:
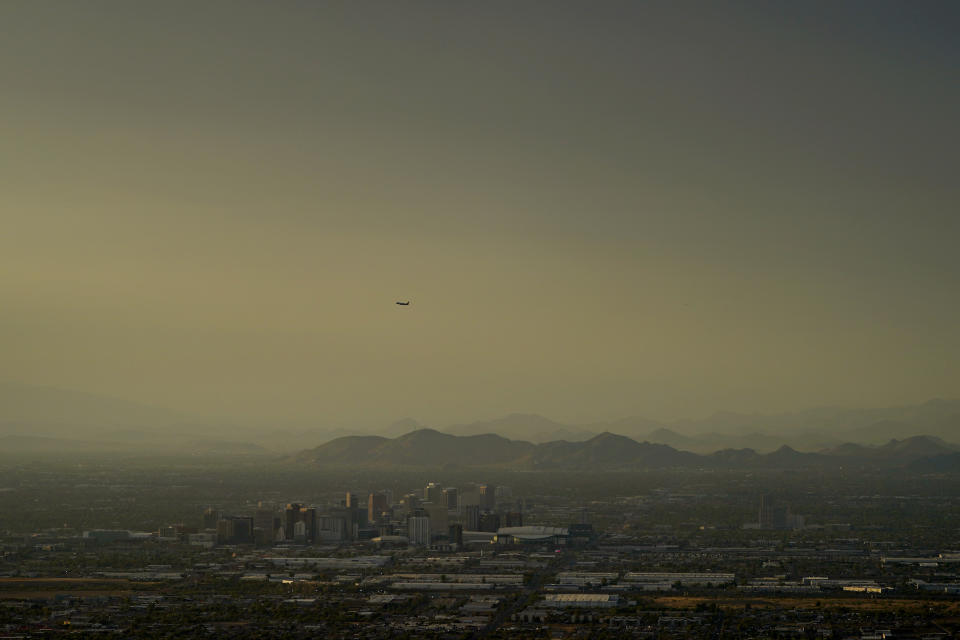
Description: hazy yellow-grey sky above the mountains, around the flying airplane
0,0,960,424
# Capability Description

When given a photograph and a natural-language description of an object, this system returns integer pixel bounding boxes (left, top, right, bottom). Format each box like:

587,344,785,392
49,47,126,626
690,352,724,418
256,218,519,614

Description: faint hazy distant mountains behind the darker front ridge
0,382,960,460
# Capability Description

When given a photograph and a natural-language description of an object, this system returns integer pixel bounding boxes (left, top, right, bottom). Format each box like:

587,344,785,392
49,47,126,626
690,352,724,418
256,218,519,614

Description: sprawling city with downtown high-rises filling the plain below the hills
0,462,960,640
